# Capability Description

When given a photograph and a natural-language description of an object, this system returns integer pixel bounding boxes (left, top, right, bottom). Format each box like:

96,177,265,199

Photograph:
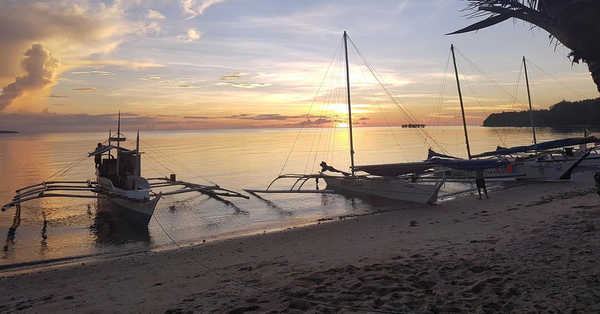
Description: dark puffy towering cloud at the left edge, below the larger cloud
0,44,58,110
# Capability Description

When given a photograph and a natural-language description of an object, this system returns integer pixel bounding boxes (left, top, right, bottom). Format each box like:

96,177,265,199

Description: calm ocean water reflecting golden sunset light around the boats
0,127,592,265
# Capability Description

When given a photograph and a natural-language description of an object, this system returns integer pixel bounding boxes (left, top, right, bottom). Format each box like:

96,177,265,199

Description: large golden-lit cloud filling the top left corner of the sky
0,0,131,79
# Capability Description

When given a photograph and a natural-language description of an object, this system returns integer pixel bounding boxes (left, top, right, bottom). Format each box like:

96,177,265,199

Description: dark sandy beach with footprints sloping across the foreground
0,175,600,313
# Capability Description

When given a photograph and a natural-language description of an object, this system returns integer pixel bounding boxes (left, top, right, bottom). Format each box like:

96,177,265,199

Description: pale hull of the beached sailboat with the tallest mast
324,176,443,204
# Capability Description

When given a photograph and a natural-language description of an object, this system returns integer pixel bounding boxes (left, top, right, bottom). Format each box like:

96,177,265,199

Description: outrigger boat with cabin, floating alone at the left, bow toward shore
2,113,248,227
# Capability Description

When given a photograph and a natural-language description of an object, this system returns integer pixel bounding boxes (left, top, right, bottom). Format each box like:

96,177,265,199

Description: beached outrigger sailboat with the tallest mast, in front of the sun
245,32,444,204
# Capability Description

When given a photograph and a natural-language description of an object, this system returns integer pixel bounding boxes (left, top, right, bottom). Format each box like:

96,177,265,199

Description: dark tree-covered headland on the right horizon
483,98,600,128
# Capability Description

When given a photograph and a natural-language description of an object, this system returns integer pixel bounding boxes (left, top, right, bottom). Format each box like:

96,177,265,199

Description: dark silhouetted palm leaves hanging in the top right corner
448,0,600,91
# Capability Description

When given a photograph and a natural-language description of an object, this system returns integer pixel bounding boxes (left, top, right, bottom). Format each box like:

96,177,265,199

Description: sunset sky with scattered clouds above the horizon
0,0,598,132
